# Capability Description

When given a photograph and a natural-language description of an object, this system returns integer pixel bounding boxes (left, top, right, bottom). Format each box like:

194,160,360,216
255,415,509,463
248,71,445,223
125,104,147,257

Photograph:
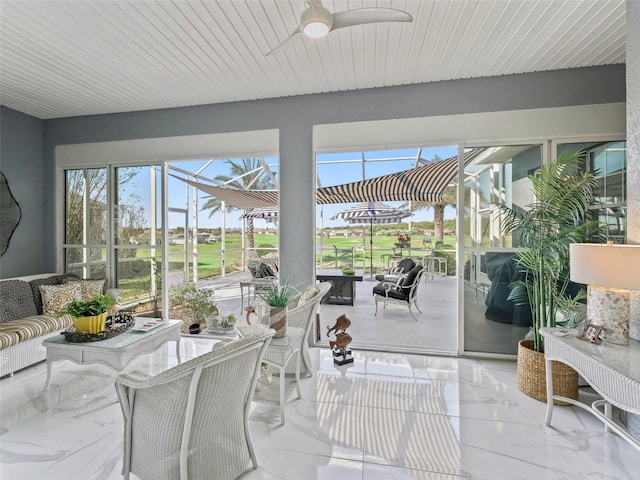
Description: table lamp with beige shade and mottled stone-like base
569,243,640,345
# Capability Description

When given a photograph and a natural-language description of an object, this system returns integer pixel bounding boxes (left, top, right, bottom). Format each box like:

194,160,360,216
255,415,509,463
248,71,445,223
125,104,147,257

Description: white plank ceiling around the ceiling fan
0,0,625,119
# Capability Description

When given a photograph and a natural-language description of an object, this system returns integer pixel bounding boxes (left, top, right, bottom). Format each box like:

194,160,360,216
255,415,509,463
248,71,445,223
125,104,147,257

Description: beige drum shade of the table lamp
569,243,640,290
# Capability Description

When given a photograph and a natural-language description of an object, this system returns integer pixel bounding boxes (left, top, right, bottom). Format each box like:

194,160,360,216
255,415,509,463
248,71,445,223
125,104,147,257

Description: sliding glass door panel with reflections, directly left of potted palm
460,145,543,354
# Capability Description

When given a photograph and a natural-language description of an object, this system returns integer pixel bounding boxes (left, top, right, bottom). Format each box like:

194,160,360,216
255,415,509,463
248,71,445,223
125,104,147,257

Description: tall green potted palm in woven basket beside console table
496,151,599,401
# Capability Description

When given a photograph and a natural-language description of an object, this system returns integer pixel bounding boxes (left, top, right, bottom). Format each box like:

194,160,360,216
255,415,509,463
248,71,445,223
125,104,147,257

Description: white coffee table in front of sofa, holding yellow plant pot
42,317,182,390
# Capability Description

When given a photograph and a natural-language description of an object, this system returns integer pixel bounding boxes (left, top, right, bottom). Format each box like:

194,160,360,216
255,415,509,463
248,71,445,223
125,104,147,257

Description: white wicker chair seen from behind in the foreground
115,325,275,480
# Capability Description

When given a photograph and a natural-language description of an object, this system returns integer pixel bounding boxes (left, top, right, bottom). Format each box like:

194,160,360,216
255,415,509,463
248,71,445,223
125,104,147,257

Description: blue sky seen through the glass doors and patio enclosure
122,146,458,229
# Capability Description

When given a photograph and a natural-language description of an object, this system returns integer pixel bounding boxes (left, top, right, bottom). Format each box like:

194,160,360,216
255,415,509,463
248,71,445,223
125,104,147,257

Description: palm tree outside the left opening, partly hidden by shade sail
201,158,274,258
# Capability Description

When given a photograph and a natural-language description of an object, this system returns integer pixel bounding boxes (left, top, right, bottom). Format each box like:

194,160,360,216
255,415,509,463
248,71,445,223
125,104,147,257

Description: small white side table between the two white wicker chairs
248,327,304,425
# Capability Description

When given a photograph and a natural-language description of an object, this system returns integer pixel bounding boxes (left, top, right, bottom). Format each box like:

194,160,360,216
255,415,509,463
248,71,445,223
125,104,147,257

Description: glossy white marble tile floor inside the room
0,338,640,480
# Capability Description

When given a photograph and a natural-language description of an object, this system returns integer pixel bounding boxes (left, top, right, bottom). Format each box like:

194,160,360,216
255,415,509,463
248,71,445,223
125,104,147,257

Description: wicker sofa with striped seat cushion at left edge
0,273,78,377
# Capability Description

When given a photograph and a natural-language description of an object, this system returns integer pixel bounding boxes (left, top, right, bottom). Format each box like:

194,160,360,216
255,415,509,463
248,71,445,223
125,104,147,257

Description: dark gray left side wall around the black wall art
0,107,45,278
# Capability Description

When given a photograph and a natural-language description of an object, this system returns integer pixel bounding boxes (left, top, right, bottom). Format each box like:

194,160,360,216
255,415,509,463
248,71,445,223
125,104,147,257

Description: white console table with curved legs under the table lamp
540,328,640,450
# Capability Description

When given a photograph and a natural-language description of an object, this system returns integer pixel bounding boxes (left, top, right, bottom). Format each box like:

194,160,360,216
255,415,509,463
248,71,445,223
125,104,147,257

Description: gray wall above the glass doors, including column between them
0,65,625,281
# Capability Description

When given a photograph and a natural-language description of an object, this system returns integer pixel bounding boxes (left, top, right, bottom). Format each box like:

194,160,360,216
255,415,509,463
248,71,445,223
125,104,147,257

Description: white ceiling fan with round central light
267,0,413,55
